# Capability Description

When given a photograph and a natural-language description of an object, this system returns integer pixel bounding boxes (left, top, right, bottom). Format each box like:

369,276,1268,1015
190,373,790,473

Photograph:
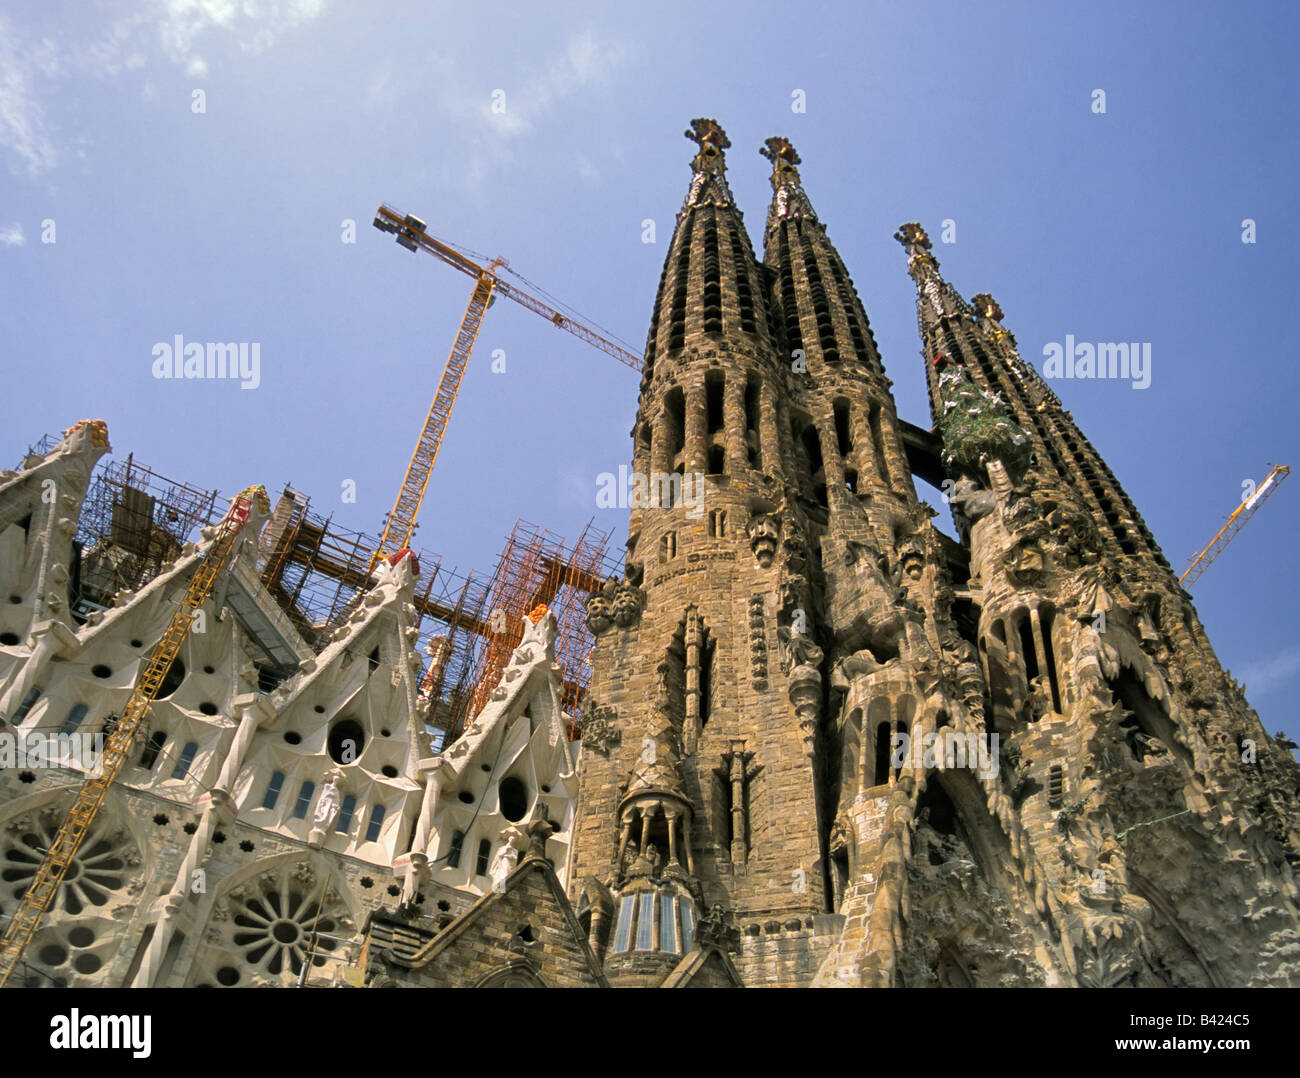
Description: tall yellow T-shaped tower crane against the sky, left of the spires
369,205,642,572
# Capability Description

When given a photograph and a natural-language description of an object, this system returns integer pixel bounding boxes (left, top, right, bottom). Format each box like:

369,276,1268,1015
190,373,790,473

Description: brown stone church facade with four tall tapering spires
568,120,1300,986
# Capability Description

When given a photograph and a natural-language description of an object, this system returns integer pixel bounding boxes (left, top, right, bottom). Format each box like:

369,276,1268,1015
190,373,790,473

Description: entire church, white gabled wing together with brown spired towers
0,120,1300,987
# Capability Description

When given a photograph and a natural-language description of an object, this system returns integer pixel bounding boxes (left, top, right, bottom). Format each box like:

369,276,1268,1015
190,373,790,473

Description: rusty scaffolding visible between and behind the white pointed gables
17,436,621,750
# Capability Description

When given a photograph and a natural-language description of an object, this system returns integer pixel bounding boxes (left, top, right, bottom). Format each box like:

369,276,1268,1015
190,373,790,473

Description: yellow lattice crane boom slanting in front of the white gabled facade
0,486,269,988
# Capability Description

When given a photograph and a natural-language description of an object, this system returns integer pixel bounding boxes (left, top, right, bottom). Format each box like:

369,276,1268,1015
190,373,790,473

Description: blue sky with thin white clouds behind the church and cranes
0,0,1300,736
